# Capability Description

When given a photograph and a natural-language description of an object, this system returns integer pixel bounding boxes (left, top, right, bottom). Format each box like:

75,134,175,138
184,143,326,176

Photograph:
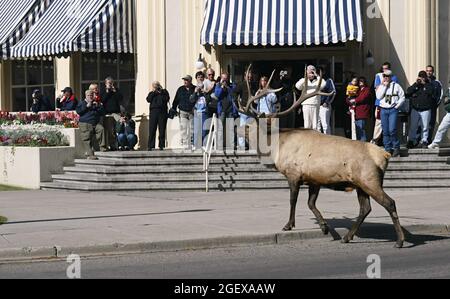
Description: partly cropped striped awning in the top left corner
0,0,53,59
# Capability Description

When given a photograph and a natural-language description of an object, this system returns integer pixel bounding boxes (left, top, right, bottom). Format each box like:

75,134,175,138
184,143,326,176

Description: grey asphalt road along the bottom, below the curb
0,235,450,279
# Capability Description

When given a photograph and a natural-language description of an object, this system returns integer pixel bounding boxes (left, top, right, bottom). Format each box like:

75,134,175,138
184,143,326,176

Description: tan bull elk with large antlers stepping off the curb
238,66,405,248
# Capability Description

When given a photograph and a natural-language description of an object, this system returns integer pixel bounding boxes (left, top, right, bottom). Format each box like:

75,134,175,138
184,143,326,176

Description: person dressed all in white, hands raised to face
295,65,326,131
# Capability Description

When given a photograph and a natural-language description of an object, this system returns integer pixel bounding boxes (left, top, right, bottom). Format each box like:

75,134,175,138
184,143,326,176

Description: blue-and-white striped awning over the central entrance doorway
201,0,363,46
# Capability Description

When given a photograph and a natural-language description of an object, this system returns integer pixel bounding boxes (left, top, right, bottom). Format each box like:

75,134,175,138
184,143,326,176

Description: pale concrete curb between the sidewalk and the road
0,224,450,264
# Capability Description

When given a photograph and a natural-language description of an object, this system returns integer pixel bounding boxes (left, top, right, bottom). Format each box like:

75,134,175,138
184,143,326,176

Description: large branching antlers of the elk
238,65,334,119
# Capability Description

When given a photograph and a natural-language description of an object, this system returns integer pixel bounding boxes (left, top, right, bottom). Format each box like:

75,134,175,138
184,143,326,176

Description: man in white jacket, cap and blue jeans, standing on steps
377,70,406,157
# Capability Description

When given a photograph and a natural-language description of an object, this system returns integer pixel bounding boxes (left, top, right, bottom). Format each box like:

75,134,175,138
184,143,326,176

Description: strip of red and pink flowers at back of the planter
0,111,80,128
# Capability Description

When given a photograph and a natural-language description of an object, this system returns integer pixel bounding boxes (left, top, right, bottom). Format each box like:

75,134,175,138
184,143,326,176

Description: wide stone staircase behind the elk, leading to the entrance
41,149,450,192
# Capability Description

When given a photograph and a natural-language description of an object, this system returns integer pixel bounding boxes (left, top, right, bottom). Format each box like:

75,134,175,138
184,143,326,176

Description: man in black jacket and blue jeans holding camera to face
406,71,436,149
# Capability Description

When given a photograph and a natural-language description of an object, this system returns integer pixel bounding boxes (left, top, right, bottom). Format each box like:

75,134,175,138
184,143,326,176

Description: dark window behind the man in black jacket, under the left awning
80,53,136,114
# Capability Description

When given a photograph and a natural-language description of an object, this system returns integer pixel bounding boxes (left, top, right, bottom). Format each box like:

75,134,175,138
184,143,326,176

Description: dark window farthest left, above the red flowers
11,60,55,112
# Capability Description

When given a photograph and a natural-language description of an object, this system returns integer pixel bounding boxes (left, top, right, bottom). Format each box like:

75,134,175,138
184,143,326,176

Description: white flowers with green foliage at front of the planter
0,124,70,147
